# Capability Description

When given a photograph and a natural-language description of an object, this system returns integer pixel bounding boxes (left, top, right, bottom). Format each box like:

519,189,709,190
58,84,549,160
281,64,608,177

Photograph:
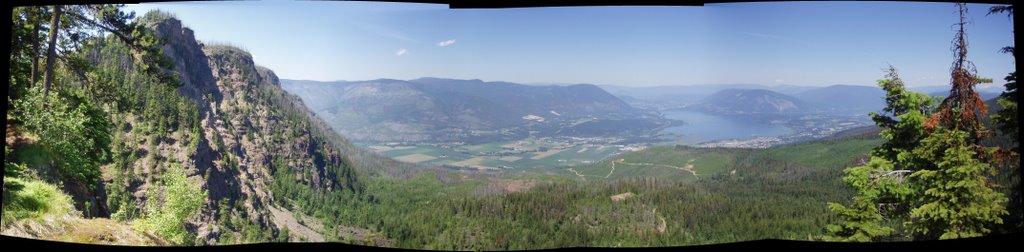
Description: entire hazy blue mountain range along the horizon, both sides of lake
281,78,998,142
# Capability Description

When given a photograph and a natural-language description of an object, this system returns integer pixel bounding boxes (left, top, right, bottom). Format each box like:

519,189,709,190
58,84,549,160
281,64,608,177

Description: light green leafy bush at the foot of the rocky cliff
136,164,207,245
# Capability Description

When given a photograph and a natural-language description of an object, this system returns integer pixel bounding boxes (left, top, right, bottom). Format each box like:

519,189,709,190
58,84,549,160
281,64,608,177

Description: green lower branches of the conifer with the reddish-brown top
910,123,1008,239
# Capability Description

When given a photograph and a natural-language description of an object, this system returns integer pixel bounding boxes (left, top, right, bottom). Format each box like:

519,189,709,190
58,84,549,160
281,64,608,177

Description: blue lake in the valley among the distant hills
662,111,792,143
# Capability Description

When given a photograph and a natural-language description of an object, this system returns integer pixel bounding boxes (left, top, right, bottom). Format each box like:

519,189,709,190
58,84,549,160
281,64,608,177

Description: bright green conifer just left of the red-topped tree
824,66,934,242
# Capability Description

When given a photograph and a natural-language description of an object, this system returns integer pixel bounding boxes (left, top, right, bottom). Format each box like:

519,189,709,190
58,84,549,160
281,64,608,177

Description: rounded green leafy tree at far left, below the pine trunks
14,87,111,184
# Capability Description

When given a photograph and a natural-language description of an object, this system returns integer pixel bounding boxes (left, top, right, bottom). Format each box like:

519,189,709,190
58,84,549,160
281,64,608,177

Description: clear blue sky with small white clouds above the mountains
126,0,1015,87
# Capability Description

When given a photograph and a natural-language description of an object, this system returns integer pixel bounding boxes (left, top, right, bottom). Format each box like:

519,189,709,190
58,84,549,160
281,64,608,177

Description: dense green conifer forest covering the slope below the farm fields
294,138,880,247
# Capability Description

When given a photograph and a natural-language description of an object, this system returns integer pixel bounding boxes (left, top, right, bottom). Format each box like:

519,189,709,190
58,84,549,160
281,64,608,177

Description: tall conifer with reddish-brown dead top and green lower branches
909,3,1008,239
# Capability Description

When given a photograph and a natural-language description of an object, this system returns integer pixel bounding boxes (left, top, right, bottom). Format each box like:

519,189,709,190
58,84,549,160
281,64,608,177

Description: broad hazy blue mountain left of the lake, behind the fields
282,78,658,141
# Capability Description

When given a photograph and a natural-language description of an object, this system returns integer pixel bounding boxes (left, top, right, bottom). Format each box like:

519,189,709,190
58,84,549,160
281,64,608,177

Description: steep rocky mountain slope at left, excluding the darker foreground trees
4,11,385,245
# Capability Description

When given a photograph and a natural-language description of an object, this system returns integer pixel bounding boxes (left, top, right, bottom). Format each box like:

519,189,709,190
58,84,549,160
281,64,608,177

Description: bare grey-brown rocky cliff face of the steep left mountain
97,14,358,244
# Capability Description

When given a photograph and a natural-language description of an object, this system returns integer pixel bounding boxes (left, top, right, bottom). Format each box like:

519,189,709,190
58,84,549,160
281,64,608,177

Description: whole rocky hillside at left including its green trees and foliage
4,6,366,244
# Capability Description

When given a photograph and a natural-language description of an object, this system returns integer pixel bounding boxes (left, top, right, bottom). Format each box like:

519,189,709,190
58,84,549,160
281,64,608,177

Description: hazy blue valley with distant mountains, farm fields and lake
282,78,905,171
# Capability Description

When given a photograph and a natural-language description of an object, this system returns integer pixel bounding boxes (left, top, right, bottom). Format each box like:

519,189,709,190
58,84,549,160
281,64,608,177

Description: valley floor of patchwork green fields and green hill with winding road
372,138,881,185
